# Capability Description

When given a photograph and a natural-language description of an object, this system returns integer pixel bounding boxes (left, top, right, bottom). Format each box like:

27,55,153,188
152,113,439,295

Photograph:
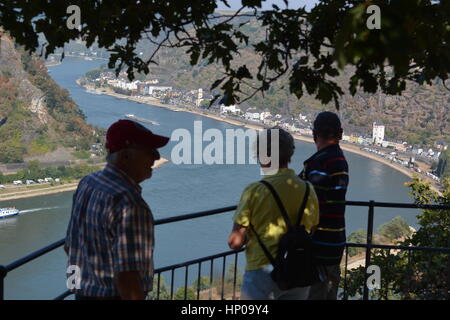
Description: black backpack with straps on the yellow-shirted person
250,180,327,291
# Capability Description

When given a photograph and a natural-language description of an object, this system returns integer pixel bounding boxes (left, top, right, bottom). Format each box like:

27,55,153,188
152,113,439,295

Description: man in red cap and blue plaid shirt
64,120,169,300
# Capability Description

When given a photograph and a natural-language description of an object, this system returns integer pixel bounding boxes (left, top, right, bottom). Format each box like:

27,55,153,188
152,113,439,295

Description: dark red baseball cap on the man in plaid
106,120,170,153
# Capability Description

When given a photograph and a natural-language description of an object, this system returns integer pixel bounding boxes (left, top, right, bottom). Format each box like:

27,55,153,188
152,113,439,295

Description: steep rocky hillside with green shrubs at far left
0,35,98,163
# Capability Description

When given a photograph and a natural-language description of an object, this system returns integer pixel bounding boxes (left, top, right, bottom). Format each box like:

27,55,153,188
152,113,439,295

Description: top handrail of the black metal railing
1,201,450,272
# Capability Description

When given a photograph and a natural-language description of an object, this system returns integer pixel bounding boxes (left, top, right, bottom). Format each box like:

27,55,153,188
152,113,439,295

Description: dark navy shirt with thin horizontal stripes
299,144,349,265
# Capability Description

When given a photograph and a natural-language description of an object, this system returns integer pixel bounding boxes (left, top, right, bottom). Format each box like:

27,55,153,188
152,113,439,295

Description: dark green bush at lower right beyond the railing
342,178,450,300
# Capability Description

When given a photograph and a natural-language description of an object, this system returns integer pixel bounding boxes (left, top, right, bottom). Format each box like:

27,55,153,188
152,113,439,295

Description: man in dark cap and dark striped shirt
300,112,349,300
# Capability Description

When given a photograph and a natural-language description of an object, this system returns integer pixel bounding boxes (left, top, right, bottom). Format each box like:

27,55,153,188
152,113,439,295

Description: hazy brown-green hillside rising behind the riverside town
138,21,450,145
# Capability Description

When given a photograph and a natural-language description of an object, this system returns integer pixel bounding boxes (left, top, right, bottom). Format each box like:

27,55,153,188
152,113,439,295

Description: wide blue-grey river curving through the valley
0,58,418,299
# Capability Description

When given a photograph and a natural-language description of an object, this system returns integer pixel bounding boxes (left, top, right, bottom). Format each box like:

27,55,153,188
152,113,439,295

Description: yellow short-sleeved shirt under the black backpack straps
233,168,319,270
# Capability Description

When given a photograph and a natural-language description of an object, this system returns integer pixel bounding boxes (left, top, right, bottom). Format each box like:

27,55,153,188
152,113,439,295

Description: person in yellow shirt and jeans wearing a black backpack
228,128,319,300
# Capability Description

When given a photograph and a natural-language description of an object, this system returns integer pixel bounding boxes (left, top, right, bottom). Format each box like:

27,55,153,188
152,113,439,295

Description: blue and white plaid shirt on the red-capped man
65,165,154,296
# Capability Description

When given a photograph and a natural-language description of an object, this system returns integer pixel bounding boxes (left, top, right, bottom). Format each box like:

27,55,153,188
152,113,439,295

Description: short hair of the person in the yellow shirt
256,126,295,164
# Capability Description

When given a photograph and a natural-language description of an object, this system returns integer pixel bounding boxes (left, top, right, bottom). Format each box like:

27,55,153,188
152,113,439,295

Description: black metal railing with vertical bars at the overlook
0,201,450,300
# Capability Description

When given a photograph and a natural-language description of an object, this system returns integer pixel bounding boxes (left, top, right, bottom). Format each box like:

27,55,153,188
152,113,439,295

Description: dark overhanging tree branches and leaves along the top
0,0,450,106
